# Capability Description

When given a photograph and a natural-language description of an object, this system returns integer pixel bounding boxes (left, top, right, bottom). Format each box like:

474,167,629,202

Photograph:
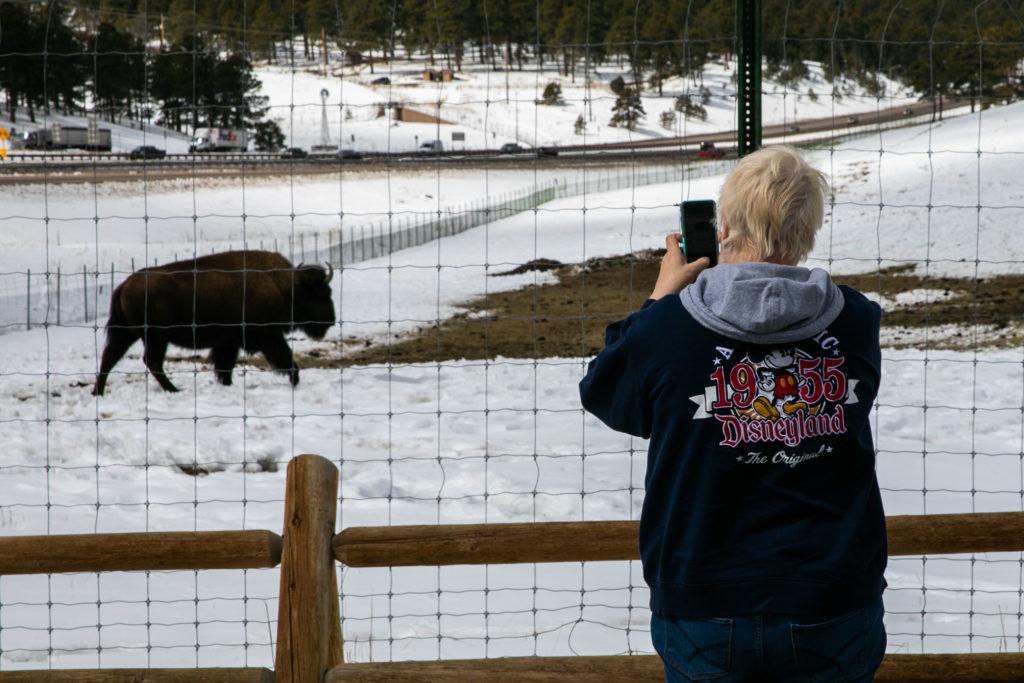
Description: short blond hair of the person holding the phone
719,146,828,263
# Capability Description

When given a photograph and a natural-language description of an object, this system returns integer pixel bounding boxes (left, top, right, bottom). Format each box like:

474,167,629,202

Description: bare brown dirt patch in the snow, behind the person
327,251,1024,367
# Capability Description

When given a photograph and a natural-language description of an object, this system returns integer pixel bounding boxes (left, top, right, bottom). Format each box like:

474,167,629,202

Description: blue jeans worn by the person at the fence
650,597,886,683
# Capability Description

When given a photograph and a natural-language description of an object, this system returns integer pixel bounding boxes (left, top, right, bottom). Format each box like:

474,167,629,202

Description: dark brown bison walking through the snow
92,251,335,396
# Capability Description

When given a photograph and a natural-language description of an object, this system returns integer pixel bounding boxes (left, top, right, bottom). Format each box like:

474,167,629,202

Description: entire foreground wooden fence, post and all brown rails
0,456,1024,683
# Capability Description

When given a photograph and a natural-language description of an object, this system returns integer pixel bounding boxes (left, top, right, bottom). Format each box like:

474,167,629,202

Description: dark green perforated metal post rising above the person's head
736,0,761,157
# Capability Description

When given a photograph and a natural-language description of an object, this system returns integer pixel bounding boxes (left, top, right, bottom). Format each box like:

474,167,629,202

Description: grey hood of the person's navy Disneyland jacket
679,263,844,344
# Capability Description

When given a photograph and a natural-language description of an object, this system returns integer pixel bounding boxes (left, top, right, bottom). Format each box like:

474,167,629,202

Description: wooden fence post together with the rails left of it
0,456,341,683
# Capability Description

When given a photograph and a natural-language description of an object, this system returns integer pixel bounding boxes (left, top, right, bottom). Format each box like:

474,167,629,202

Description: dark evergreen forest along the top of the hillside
0,0,1024,130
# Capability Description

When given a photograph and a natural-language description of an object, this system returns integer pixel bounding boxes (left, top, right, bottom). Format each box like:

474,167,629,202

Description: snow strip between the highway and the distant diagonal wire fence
0,169,581,272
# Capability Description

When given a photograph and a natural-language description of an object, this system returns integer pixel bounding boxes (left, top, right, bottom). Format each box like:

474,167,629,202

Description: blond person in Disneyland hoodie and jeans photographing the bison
580,147,887,683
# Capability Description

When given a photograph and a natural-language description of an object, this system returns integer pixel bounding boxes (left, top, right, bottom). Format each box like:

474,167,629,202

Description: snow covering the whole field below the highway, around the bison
0,100,1024,669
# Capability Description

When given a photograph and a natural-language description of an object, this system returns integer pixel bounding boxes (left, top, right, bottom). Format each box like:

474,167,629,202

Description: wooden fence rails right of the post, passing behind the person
324,512,1024,683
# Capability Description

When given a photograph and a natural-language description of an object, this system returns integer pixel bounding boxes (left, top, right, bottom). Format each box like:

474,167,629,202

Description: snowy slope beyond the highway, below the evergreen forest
256,61,918,152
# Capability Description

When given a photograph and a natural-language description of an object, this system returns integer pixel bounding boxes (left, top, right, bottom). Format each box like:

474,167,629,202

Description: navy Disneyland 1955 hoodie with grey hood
580,263,887,617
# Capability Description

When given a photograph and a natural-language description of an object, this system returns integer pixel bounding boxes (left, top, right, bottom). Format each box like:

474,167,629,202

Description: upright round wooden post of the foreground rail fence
274,456,342,683
